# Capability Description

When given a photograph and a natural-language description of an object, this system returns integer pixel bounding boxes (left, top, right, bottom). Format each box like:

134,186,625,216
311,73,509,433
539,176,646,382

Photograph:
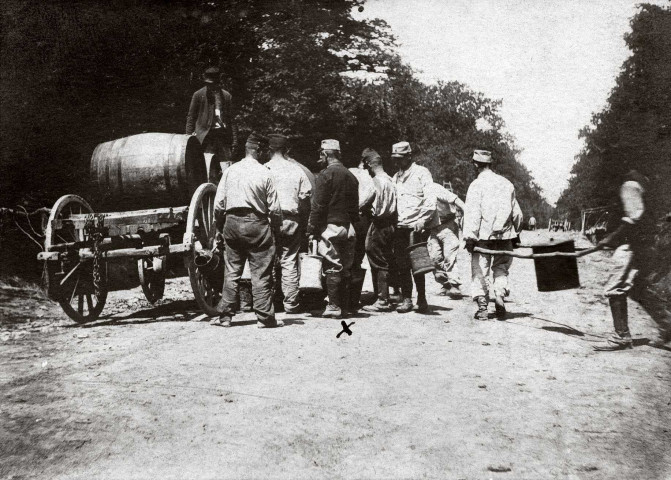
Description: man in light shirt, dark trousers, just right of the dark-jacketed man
362,148,398,312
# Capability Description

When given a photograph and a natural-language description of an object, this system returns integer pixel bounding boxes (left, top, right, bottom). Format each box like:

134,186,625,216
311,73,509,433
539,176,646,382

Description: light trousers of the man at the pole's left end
471,240,513,298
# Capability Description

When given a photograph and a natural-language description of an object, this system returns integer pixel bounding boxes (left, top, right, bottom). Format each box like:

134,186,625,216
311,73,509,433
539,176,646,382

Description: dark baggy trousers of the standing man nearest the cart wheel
222,213,275,324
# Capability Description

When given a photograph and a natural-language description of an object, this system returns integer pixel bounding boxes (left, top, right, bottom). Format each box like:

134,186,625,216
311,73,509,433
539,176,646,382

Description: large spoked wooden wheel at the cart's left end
44,195,107,323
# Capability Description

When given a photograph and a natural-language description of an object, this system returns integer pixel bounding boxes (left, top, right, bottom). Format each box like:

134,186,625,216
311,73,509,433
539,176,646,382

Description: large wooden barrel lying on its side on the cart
91,133,207,210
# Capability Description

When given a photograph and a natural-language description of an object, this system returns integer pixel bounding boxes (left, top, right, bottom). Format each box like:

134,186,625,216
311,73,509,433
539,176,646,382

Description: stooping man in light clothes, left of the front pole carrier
426,183,464,299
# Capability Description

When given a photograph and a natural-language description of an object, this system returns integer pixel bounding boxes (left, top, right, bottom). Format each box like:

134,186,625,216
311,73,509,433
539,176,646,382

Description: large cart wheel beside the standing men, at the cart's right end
184,183,223,317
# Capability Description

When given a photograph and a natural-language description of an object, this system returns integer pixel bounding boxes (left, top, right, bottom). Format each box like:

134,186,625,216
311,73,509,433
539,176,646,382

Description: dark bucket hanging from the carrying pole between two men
531,240,580,292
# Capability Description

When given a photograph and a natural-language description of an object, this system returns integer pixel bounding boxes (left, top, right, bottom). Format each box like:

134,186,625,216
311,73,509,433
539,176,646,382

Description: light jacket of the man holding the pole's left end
464,170,523,240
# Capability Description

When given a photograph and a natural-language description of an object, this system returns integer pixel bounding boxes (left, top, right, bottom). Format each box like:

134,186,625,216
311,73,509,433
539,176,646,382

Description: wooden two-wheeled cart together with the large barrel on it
38,134,223,323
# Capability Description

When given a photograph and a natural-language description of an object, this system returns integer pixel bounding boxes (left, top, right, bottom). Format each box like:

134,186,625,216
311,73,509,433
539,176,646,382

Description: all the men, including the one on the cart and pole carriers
186,68,646,349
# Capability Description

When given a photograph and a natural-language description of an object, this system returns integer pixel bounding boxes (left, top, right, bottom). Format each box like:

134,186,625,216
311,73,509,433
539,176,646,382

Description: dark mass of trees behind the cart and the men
0,0,549,223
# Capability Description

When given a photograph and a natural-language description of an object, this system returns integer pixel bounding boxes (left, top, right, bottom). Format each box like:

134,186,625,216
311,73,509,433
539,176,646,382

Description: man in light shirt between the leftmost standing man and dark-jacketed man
266,134,312,313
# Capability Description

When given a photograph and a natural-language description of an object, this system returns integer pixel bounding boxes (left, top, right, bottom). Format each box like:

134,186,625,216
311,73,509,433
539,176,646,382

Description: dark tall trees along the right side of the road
557,4,671,306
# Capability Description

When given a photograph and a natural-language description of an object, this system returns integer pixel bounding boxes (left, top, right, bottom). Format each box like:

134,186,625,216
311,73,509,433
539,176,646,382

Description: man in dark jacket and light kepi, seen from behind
307,140,359,318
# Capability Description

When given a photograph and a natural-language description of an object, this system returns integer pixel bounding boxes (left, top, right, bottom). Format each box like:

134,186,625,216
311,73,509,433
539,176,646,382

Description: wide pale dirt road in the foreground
0,234,671,479
